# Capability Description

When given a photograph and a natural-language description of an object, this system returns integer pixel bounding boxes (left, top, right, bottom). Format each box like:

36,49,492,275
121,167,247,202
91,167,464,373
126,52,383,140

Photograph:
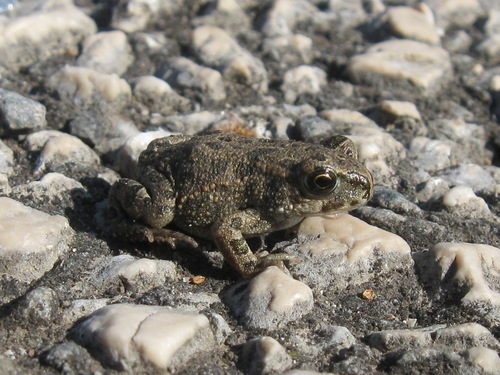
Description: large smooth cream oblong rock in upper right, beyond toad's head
347,40,452,95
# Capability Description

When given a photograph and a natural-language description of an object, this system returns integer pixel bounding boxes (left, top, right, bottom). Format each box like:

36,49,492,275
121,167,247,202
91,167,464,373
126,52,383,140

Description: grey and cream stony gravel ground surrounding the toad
0,0,500,375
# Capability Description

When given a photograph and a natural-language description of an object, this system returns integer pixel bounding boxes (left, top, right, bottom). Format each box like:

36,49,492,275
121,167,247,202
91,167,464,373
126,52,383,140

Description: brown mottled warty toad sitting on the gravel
109,132,373,277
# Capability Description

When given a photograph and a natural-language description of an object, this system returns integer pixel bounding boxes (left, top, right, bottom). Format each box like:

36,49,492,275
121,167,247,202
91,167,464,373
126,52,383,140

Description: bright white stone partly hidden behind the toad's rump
115,129,177,178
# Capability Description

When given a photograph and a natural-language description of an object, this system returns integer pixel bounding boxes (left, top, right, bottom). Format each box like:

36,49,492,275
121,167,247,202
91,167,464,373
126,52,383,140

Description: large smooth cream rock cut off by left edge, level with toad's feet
0,197,73,283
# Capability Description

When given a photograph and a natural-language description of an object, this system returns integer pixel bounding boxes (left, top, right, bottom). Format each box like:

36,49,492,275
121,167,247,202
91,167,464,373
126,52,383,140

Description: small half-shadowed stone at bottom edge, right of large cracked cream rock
242,336,292,375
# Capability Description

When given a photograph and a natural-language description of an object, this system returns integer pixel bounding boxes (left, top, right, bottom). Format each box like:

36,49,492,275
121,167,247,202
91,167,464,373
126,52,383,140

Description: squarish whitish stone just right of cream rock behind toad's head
410,137,454,172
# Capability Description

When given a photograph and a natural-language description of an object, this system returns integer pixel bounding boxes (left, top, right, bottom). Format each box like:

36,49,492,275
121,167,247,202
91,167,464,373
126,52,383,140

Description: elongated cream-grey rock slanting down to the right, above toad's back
192,26,268,93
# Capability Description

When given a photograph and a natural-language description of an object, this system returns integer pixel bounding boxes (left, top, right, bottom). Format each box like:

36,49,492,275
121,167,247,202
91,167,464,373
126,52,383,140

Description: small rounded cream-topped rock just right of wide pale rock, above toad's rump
133,76,191,115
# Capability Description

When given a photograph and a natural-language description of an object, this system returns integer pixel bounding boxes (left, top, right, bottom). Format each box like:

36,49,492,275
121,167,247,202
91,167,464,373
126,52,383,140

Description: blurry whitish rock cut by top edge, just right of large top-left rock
111,0,183,33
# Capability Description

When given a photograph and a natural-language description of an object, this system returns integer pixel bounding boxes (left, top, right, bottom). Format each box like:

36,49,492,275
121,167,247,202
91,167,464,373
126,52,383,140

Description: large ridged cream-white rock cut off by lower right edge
428,242,500,306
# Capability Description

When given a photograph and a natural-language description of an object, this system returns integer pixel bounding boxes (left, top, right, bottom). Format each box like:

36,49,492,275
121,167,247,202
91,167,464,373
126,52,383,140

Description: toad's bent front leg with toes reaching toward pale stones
212,210,294,278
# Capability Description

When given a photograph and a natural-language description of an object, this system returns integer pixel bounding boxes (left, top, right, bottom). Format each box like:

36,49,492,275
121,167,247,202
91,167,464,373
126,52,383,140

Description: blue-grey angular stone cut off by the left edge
0,88,47,136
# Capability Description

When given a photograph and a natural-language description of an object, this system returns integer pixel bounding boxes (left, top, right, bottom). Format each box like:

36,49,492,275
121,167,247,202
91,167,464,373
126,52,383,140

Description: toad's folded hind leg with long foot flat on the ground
109,168,198,248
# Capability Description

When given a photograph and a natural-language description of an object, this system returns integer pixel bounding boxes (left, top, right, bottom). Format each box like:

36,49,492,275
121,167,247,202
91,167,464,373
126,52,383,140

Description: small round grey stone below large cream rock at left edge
23,286,60,325
